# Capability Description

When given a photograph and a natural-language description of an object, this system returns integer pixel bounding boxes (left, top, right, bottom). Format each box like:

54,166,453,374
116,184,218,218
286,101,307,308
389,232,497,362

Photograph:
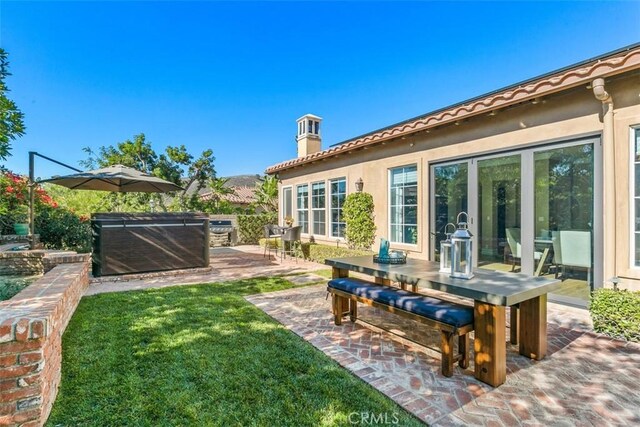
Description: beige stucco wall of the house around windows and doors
267,46,640,289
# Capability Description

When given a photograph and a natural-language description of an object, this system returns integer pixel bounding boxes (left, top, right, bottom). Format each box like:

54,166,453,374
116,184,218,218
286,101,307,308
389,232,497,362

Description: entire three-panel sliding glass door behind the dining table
431,139,602,304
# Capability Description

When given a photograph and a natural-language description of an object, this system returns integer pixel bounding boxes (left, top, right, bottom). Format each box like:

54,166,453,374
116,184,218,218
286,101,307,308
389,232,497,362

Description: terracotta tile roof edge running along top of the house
265,43,640,174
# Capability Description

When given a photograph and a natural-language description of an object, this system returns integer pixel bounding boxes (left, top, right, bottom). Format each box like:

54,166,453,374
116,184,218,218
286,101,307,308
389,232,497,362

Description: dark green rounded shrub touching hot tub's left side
35,207,91,253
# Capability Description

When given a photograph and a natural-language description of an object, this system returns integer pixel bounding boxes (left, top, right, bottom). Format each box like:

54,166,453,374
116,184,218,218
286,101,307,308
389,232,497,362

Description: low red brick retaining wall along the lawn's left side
0,256,90,426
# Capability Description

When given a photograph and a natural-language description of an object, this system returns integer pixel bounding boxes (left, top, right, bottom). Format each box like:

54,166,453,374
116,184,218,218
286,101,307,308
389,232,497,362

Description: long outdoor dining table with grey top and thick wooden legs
325,255,560,387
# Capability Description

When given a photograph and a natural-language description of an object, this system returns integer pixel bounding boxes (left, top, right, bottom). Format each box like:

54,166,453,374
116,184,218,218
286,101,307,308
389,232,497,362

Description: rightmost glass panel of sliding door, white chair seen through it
534,144,594,300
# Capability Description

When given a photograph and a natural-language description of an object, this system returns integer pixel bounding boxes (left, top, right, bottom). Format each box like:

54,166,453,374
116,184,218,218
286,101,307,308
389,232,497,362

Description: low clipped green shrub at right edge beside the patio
589,289,640,342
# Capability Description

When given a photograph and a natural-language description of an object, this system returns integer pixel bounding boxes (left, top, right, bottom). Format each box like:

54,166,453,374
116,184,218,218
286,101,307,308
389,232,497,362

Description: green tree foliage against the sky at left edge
0,48,25,160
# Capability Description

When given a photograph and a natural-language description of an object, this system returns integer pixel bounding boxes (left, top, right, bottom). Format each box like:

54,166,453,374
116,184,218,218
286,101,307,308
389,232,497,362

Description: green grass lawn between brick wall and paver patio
48,278,420,426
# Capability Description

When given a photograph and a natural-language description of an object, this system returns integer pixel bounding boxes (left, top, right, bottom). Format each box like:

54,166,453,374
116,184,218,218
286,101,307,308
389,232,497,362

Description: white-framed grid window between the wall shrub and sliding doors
389,165,418,244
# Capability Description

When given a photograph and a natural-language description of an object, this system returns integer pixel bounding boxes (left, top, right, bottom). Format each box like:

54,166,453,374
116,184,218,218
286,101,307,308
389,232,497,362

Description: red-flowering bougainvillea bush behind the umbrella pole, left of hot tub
0,171,91,252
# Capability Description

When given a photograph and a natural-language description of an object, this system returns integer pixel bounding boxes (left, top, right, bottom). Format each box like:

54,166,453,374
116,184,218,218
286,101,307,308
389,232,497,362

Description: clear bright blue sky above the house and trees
0,0,640,177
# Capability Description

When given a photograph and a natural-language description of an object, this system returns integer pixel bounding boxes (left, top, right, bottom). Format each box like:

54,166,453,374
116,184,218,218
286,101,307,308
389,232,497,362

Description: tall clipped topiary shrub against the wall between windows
342,192,376,250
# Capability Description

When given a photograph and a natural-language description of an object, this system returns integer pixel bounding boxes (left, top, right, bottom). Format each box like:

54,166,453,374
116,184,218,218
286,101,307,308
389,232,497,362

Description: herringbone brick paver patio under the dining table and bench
247,285,640,426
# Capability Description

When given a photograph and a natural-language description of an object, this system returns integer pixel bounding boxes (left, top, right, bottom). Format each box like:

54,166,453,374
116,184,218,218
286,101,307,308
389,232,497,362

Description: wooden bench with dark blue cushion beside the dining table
327,277,473,377
